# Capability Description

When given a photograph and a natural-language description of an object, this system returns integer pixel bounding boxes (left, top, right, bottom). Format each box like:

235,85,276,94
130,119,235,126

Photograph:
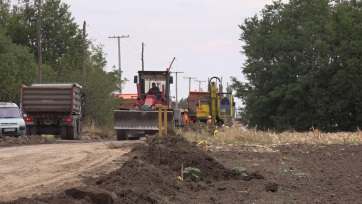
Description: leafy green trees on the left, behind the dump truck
0,0,120,127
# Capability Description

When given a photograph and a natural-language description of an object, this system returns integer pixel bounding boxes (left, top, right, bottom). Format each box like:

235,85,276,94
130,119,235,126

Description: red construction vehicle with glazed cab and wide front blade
114,70,175,140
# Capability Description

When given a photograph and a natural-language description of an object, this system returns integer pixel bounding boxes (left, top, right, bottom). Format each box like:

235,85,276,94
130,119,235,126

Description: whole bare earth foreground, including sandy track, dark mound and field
0,135,362,203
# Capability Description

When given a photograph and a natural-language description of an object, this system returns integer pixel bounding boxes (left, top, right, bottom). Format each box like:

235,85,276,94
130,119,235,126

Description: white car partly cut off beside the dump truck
0,102,26,136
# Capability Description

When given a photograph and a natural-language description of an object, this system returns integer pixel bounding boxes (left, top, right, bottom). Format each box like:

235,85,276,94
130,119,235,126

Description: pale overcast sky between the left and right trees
62,0,282,106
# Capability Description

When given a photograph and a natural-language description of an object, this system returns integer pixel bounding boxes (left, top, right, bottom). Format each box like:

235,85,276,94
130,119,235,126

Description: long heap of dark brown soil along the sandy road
4,135,263,203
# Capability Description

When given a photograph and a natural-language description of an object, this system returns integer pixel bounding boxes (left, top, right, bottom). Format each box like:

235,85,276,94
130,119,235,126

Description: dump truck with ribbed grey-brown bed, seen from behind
20,83,84,140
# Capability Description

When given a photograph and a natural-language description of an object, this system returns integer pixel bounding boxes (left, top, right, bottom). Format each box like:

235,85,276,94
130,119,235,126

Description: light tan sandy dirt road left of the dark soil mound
0,141,141,201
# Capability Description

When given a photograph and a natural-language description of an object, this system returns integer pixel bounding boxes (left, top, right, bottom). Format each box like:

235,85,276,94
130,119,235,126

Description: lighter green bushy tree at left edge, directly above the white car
0,26,37,104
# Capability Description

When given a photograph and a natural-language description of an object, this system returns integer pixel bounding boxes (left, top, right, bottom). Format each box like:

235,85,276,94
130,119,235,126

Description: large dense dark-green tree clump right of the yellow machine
232,0,362,131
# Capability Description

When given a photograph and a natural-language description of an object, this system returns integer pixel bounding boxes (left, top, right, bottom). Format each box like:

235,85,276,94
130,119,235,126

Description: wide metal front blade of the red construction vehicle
114,110,175,130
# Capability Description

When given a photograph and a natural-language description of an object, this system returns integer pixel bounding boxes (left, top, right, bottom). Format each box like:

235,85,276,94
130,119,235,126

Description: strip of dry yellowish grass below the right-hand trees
176,123,362,147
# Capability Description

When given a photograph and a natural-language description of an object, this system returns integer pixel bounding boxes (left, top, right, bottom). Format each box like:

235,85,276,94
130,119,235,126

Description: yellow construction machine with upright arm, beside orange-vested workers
187,77,235,126
